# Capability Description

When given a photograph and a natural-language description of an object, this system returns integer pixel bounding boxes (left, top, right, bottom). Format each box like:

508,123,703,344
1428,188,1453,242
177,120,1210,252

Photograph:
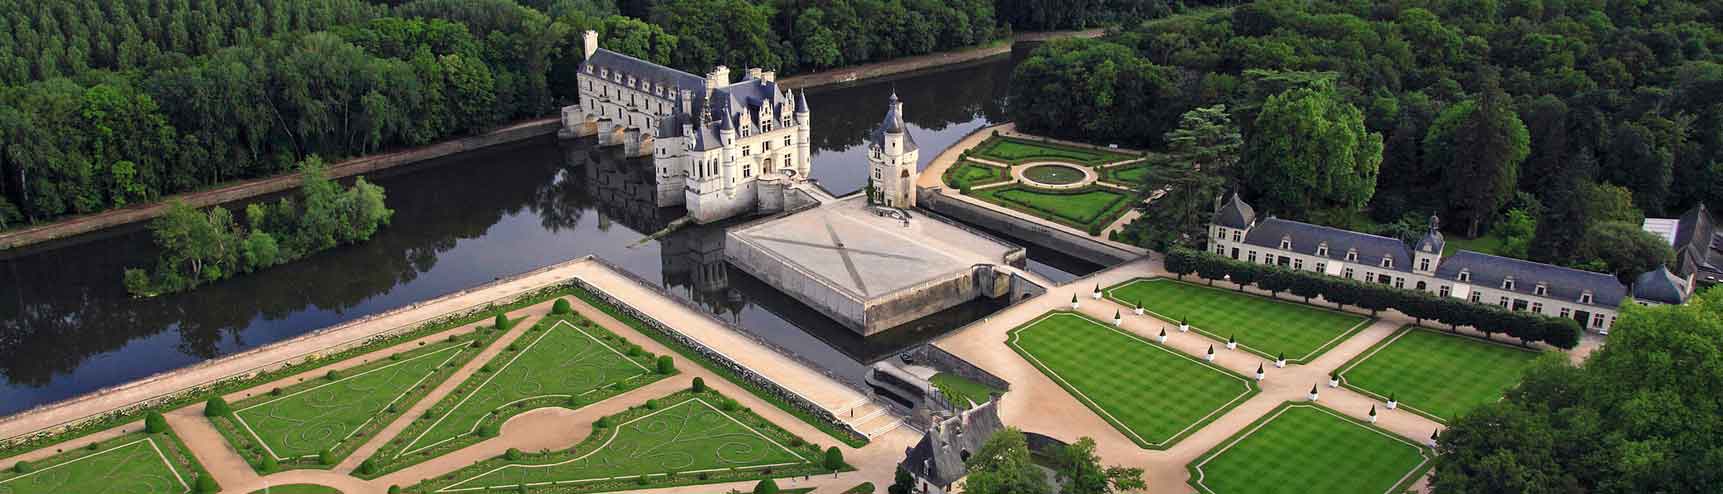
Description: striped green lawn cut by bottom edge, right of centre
1187,403,1434,494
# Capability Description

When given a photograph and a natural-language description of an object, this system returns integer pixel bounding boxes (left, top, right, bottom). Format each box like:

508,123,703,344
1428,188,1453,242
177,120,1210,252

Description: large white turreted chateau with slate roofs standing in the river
560,31,812,224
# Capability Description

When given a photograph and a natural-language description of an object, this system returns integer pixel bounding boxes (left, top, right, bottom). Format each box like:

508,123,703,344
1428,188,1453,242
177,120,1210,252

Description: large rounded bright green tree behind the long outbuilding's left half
1244,84,1382,217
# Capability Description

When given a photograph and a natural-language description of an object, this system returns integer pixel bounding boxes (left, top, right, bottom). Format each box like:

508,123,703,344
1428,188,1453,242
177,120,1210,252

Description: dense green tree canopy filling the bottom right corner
1430,289,1723,494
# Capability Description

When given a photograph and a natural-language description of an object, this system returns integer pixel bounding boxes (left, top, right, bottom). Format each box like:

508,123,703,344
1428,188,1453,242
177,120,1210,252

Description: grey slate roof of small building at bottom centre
901,399,1005,489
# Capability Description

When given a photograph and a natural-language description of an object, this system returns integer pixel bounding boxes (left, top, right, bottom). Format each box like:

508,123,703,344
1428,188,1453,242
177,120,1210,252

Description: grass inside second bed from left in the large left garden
234,346,476,460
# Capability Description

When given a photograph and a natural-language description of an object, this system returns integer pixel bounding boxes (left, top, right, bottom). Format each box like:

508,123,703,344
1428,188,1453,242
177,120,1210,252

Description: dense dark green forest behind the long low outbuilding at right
1011,0,1723,274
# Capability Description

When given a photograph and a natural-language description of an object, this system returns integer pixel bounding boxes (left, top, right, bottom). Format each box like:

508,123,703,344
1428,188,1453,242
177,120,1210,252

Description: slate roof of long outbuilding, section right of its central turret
1435,250,1627,308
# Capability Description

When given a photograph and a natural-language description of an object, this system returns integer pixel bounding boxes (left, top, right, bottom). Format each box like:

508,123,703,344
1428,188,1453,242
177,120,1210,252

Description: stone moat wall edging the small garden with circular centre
917,188,1141,267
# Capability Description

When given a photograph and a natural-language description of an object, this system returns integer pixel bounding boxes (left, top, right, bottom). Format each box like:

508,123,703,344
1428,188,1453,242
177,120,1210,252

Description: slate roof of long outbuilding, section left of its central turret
1244,217,1411,272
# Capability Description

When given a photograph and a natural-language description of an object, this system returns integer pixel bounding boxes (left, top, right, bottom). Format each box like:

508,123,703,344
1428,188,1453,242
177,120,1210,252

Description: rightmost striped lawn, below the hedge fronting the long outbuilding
1340,325,1539,423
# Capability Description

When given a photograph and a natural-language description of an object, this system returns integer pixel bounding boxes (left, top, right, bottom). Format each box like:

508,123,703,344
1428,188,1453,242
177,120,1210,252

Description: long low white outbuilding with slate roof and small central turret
1210,193,1694,334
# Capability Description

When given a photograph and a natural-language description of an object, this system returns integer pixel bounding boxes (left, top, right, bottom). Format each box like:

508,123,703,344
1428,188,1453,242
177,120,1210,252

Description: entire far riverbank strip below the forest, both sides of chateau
0,29,1104,253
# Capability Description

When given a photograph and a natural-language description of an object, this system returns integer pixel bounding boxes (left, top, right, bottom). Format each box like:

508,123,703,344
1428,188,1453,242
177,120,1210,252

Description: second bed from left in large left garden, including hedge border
205,318,512,473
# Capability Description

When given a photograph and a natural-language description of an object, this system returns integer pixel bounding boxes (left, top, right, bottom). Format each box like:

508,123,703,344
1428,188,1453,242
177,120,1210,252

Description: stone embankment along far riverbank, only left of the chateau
0,119,560,251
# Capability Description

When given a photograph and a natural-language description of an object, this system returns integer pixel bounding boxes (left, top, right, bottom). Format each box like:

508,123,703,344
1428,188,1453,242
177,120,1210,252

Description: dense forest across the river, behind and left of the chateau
0,0,1047,229
